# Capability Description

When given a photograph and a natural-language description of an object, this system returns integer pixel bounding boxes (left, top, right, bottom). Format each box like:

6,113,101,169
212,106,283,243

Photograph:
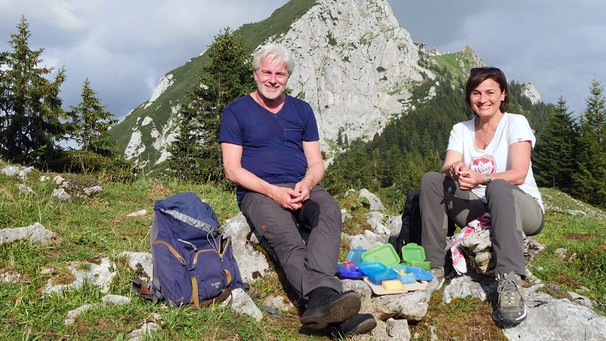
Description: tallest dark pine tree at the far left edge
0,17,66,167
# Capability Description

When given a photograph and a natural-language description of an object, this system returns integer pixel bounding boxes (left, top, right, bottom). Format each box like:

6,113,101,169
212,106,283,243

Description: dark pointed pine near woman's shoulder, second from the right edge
532,97,577,193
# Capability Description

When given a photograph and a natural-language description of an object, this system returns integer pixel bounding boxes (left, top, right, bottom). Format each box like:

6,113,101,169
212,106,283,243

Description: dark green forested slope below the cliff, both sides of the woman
324,51,606,209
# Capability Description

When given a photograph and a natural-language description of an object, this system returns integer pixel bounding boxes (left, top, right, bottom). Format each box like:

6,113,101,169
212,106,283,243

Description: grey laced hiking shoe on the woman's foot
497,271,526,324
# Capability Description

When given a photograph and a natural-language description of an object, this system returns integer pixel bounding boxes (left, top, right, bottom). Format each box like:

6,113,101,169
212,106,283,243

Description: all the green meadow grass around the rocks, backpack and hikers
0,162,606,340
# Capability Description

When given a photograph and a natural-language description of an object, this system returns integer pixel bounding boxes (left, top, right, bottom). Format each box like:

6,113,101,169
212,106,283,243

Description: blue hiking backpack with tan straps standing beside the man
144,192,244,307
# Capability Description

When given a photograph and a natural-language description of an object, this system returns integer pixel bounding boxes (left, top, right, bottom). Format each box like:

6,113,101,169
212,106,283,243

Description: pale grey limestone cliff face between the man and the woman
276,0,432,150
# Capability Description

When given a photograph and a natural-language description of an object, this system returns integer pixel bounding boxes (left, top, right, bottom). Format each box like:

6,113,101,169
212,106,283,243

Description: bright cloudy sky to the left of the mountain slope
0,0,287,117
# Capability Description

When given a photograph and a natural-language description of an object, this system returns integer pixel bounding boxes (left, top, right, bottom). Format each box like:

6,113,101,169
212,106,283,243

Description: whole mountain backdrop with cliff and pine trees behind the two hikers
0,0,606,209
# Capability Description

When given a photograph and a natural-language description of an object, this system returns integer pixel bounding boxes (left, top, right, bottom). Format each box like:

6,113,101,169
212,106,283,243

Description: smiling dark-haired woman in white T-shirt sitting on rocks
420,67,544,324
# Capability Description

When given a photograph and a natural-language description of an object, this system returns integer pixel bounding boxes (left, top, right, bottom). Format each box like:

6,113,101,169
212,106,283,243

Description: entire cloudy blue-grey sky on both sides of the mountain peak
0,0,606,119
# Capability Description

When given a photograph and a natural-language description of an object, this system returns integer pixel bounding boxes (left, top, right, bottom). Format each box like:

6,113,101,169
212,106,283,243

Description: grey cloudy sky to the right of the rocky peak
390,0,606,113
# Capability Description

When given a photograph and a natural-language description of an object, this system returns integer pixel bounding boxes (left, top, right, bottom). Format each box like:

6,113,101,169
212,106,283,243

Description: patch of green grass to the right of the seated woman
530,189,606,316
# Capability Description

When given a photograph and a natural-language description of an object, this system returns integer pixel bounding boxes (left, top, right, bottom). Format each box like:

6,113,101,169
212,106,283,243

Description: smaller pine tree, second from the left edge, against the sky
68,79,117,156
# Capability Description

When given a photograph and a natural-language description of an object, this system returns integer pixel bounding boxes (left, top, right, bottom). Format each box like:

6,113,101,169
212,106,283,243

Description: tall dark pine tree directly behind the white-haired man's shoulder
168,28,255,182
